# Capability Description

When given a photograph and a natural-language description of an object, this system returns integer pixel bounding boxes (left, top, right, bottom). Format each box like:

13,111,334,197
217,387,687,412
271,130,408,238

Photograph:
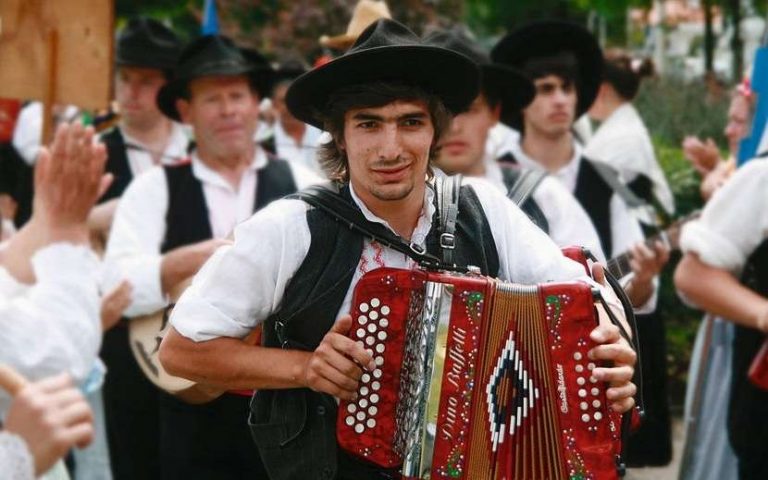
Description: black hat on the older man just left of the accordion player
156,35,274,122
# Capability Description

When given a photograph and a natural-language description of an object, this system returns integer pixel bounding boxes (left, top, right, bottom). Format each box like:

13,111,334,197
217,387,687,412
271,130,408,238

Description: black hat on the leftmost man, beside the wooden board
115,17,181,70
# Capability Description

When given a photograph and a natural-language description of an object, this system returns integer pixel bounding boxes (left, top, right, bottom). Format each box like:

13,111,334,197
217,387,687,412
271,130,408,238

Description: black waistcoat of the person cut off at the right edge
728,240,768,460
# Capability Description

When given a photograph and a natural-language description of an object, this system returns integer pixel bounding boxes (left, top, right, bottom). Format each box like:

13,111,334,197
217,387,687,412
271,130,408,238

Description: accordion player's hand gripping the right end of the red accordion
588,325,637,413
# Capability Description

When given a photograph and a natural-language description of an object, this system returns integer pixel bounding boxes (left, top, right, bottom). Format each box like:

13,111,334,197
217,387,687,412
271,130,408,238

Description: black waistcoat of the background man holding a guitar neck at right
573,157,613,258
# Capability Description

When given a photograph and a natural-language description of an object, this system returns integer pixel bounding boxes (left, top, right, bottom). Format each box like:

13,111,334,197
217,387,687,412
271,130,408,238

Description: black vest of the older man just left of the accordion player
160,160,296,253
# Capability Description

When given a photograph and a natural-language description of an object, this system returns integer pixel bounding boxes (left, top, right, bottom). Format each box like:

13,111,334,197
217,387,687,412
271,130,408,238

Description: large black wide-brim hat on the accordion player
285,19,480,130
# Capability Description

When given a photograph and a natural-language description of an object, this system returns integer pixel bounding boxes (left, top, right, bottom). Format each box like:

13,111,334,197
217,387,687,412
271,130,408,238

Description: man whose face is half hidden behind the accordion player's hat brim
424,27,605,261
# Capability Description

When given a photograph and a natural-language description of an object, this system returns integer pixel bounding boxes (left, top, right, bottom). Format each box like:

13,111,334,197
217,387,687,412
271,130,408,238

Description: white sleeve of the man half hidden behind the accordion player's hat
533,177,605,262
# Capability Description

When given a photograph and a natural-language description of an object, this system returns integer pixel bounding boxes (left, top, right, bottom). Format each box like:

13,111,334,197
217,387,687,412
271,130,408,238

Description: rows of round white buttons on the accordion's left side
344,298,390,434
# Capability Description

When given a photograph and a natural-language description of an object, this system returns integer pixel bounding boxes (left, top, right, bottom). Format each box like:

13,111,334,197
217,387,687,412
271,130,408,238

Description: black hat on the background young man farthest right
491,20,603,121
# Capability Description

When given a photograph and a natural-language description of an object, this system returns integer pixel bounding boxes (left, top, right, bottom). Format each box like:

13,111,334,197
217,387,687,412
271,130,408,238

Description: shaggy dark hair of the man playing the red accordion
318,81,452,182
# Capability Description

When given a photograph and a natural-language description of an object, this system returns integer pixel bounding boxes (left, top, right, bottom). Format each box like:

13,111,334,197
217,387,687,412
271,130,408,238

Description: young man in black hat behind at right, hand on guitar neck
492,21,669,313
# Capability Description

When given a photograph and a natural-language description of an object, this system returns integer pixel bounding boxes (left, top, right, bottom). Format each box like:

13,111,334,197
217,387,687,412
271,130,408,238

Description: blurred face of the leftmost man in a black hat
115,67,166,128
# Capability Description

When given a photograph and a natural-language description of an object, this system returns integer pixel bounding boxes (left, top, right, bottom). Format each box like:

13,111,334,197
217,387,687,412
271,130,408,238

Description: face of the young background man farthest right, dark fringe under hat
523,75,577,138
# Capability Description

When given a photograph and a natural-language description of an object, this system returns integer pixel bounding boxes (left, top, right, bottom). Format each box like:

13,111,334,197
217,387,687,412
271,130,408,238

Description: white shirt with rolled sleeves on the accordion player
170,178,615,341
